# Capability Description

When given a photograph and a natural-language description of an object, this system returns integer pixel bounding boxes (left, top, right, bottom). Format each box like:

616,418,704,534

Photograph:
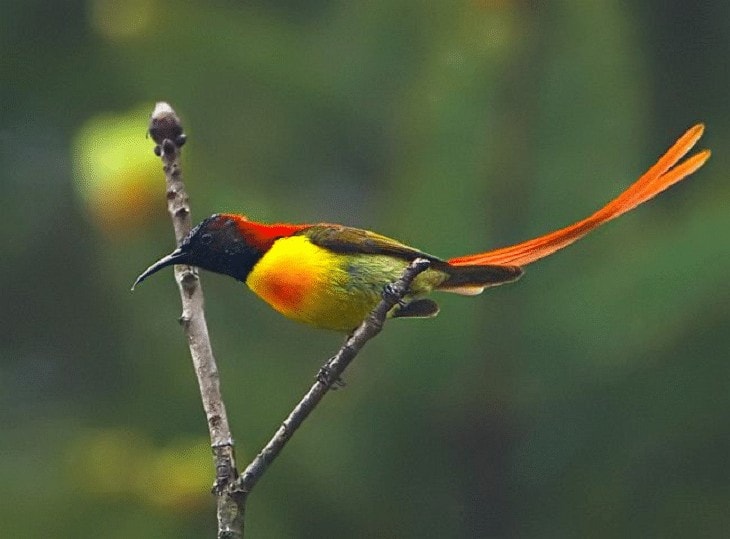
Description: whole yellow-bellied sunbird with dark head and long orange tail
132,124,710,332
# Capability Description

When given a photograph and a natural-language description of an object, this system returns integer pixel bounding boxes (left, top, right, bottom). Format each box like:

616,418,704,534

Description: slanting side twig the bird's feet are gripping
231,258,430,499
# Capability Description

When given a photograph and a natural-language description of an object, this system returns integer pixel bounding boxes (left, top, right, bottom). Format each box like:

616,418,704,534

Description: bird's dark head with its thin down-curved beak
132,214,262,290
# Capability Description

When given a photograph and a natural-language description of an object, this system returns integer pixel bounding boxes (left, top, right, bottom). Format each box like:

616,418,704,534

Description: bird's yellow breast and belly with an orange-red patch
246,236,445,331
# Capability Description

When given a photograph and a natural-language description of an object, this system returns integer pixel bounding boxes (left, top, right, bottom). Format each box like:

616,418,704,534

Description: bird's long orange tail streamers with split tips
448,124,710,266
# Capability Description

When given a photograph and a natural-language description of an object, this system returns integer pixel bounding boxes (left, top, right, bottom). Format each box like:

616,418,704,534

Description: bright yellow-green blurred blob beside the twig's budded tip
72,104,164,233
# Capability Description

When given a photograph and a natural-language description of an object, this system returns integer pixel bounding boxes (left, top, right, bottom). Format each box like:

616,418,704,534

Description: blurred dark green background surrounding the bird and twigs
0,0,730,538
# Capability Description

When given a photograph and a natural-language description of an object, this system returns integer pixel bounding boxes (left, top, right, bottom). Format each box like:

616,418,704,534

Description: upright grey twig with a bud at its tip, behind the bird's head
149,102,245,539
